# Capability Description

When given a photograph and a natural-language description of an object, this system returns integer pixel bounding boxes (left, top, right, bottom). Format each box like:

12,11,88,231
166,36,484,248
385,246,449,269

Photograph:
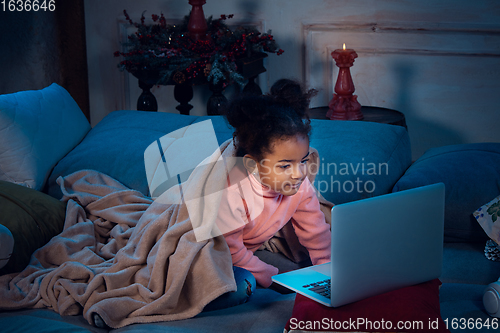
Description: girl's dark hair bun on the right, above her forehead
270,79,317,118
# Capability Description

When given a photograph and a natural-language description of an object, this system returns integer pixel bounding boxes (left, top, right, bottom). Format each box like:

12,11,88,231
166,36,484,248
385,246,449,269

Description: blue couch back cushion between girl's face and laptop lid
310,119,411,204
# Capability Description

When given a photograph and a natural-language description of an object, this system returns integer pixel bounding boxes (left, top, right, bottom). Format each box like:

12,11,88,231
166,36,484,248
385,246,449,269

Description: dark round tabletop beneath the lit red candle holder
310,106,408,130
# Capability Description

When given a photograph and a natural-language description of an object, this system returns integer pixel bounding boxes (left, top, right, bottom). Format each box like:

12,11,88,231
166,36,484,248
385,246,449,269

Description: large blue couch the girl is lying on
0,83,500,332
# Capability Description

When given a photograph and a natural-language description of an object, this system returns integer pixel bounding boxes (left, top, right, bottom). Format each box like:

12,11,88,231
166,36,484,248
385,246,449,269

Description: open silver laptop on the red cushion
272,183,445,307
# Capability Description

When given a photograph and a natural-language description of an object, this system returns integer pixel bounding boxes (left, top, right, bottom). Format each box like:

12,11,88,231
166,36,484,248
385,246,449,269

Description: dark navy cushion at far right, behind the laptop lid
393,143,500,242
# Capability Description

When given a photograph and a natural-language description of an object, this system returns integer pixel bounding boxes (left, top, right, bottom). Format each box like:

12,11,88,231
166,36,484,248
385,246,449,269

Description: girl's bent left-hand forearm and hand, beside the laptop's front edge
224,227,279,288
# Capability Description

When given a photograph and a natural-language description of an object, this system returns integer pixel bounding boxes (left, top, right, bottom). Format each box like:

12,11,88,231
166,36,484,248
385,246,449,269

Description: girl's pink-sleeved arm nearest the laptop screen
292,178,331,265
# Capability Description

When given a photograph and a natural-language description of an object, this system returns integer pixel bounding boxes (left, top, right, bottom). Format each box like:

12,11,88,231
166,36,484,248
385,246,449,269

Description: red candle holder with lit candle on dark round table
326,44,364,120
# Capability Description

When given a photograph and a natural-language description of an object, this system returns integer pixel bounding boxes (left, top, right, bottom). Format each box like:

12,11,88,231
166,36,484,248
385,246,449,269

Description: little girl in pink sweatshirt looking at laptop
217,79,331,287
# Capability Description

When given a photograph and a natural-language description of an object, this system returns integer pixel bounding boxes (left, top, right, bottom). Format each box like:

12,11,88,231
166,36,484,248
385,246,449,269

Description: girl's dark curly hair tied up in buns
224,79,316,160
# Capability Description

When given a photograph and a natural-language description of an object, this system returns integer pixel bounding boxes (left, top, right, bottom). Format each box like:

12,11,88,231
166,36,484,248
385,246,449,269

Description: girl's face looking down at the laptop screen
257,135,309,196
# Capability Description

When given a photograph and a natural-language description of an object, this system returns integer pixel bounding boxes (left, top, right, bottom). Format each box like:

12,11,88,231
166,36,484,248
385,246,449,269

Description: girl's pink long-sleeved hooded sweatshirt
217,166,331,287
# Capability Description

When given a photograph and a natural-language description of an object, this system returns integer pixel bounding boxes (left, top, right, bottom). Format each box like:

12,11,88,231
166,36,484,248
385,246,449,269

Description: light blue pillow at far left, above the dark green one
0,83,90,190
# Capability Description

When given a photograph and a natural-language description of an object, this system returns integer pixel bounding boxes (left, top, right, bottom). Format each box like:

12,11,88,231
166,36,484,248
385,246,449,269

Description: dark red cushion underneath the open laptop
285,279,449,332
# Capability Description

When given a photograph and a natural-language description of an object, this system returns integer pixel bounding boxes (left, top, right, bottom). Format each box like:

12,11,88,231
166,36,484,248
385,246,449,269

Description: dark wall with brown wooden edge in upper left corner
0,0,90,118
